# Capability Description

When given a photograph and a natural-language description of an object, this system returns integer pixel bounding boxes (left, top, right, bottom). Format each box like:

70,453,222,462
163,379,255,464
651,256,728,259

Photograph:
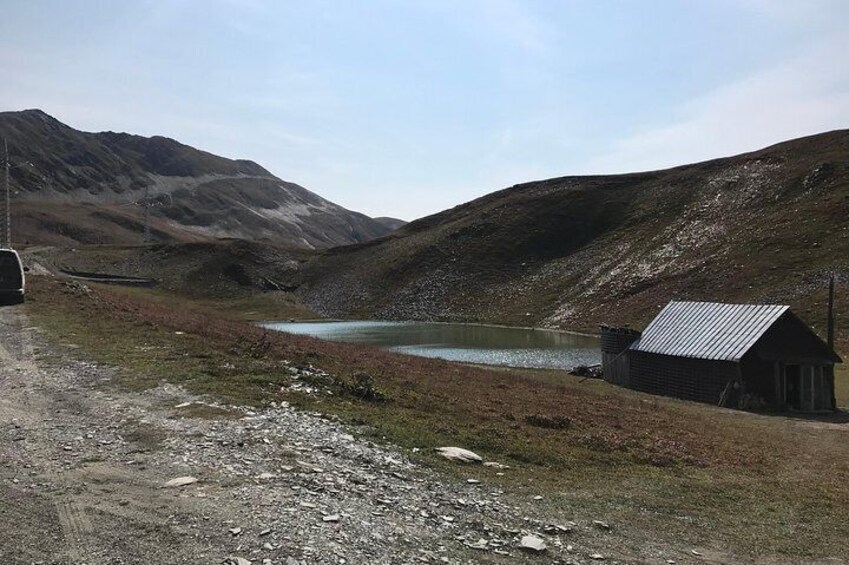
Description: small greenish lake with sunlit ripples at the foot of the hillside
262,321,601,369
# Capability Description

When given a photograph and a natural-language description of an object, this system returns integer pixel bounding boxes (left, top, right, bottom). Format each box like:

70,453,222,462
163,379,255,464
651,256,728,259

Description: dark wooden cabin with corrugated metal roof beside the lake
601,301,841,412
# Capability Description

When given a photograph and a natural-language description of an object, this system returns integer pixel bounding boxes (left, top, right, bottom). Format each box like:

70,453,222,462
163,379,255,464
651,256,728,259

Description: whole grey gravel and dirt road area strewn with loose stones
0,306,636,565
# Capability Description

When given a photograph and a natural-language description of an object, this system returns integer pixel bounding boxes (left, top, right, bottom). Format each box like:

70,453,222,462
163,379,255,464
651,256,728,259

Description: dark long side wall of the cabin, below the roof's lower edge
628,350,740,404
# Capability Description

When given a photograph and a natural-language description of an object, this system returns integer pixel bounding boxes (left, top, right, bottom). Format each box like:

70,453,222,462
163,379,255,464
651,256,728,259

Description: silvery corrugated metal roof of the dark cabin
631,302,788,361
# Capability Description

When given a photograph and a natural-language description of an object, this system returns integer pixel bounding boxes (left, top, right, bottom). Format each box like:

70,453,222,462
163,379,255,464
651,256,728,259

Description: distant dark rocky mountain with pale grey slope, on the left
0,110,391,248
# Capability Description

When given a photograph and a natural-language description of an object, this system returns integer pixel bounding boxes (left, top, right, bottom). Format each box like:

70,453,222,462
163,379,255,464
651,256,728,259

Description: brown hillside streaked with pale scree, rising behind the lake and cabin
300,130,849,340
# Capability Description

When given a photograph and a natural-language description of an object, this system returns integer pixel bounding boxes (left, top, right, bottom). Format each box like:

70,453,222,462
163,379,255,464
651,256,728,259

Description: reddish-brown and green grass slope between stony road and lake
27,277,849,559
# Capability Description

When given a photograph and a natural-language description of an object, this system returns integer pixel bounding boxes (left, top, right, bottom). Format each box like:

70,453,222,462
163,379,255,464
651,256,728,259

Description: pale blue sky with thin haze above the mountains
0,0,849,220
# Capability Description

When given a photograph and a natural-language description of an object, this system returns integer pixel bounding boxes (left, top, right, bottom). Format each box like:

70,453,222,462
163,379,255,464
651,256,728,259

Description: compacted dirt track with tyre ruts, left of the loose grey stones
0,307,237,565
